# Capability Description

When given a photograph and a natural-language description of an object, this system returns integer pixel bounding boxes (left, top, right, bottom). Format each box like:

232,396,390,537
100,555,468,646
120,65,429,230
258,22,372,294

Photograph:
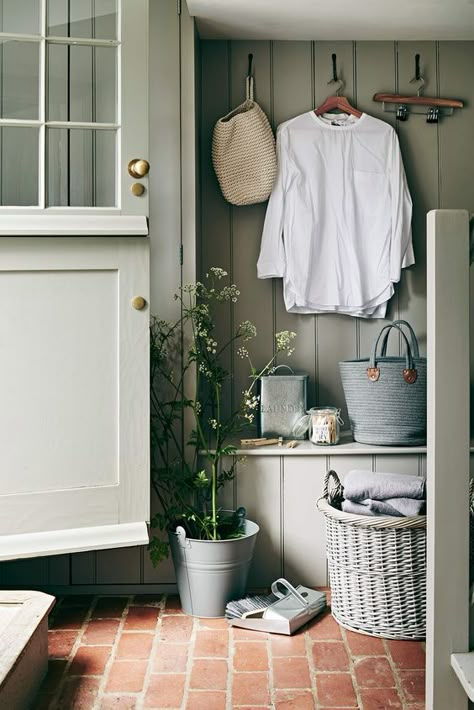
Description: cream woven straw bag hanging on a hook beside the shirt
212,76,277,205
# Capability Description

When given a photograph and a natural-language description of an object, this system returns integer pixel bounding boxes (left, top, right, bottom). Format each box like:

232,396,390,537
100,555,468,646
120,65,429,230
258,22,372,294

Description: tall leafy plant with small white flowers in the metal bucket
152,267,296,540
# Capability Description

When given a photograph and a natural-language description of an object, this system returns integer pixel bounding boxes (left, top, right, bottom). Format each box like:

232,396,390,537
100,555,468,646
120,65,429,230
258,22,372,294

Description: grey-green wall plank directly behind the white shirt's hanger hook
314,42,358,428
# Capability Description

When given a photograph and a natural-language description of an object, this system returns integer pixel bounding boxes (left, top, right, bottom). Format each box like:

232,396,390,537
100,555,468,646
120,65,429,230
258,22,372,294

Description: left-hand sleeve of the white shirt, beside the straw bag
257,127,288,279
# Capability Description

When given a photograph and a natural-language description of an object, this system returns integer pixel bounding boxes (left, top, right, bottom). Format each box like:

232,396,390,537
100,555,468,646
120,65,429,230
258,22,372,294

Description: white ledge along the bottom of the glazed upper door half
0,214,148,237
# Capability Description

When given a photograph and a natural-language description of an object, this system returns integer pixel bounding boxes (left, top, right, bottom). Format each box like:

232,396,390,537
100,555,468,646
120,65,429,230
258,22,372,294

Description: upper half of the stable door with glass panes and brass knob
0,0,148,221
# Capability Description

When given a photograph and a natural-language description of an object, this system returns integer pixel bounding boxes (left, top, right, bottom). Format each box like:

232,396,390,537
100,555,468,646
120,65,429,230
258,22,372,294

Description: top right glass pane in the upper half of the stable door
47,0,117,39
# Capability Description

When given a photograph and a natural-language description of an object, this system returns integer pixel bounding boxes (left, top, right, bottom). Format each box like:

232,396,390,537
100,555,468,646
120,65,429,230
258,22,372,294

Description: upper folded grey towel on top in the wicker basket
344,470,425,503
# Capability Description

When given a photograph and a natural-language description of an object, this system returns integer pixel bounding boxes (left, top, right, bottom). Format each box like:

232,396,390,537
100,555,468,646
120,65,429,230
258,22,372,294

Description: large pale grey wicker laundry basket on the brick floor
317,471,426,640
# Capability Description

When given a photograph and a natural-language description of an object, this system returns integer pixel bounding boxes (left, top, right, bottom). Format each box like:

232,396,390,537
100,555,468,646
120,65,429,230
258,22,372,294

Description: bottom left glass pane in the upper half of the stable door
0,126,39,207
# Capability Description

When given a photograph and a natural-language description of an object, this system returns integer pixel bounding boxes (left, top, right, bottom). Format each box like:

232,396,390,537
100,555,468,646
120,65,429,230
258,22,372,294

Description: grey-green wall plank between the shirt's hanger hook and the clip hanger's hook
355,42,399,357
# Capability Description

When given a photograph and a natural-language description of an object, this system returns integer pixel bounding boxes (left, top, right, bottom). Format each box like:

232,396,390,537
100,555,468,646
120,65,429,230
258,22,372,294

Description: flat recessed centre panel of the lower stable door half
0,270,119,496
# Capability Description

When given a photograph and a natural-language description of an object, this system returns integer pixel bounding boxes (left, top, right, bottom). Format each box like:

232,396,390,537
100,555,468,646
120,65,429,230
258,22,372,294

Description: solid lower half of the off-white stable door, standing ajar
0,237,149,560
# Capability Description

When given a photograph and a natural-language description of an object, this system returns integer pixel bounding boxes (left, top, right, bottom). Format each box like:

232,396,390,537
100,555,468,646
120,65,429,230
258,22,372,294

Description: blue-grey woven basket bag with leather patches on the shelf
339,320,426,446
